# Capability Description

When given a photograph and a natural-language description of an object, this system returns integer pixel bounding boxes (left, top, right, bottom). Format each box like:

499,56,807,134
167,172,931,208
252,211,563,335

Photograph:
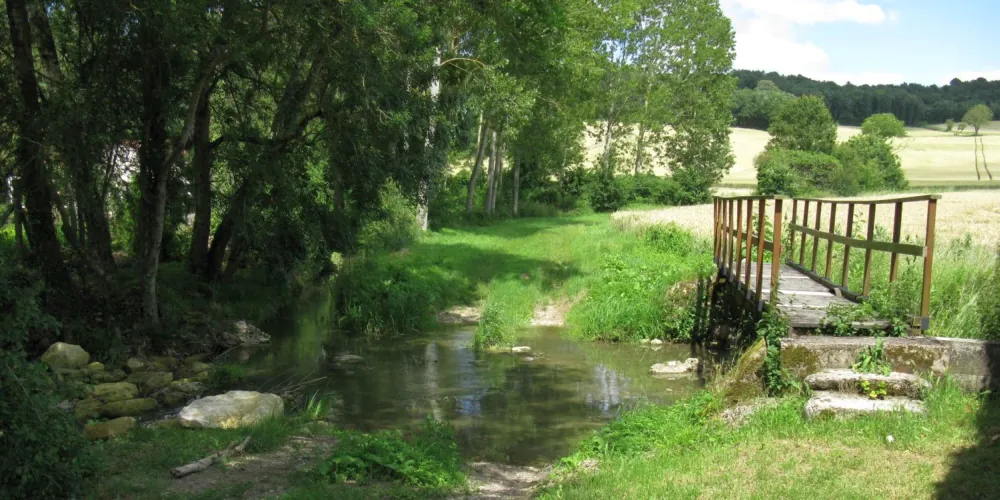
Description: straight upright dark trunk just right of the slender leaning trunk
188,89,214,274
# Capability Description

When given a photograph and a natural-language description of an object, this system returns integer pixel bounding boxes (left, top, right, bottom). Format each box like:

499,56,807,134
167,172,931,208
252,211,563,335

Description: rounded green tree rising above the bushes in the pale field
767,96,837,154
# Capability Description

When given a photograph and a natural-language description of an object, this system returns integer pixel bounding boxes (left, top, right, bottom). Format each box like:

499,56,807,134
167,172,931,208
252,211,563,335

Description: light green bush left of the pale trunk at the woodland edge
358,180,420,252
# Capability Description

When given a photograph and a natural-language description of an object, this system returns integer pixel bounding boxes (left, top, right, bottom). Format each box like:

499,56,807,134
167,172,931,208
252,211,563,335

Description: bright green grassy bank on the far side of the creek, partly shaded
337,215,713,345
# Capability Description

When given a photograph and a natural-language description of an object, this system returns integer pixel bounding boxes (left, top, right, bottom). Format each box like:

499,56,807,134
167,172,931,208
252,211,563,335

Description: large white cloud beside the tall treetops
722,0,903,85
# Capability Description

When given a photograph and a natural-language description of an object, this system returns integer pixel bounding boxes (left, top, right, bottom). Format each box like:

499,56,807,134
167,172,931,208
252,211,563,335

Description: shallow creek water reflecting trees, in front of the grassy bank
235,292,716,465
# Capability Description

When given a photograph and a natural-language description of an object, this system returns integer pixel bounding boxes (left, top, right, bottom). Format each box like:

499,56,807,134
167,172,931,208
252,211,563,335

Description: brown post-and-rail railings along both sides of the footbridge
714,195,941,331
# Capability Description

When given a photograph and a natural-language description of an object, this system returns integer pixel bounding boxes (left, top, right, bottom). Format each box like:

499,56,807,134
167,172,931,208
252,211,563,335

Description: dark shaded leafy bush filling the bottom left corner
0,350,97,499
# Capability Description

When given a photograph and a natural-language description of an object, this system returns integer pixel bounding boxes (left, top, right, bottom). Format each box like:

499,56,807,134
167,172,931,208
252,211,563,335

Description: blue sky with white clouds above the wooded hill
721,0,1000,85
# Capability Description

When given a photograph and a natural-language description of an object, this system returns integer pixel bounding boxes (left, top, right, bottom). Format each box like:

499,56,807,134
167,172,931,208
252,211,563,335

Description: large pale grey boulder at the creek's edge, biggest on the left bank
178,391,285,429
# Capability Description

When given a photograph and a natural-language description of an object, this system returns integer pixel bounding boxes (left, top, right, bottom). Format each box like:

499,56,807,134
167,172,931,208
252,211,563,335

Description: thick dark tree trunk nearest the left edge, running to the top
6,0,69,287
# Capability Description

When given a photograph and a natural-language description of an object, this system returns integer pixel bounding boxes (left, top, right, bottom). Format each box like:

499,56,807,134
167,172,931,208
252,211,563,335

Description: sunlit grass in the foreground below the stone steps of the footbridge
541,382,1000,499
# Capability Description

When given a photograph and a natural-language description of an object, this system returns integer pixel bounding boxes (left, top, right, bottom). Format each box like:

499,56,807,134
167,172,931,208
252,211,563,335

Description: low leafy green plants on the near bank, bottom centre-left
318,419,465,493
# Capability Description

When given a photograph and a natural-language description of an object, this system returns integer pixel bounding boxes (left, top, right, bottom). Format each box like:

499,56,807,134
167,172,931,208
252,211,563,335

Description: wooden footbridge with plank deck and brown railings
714,195,940,333
